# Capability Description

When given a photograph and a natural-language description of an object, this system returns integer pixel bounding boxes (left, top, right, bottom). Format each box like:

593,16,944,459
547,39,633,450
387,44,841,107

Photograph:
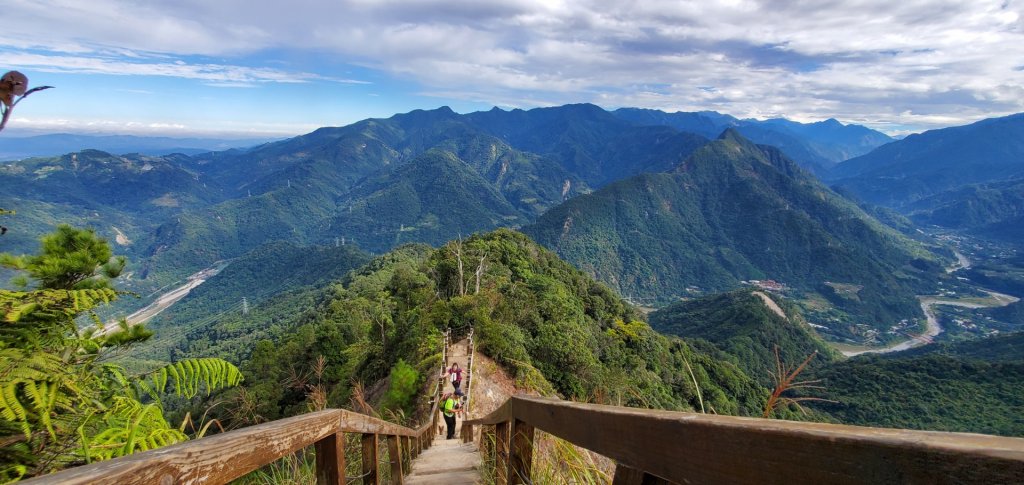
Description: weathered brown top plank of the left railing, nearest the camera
22,409,341,485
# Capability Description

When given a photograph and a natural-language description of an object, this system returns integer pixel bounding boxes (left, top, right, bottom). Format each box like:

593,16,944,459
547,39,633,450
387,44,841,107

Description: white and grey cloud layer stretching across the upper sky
0,0,1024,133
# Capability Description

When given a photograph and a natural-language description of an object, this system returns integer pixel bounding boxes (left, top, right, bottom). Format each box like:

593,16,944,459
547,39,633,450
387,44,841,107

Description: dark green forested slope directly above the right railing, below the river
808,333,1024,436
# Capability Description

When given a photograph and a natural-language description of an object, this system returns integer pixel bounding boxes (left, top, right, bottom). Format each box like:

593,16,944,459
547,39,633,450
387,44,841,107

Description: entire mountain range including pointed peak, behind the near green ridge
0,104,1019,342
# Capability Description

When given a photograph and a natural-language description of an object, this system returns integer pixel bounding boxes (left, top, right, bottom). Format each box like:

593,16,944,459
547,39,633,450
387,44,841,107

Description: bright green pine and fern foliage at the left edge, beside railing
0,226,242,482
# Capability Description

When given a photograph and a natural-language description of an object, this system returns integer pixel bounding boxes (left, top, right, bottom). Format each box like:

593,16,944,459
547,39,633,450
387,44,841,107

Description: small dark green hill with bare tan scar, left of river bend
650,289,840,386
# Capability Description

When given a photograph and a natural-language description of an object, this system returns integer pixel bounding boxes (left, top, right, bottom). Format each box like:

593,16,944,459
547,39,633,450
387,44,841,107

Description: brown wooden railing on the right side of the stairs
462,396,1024,485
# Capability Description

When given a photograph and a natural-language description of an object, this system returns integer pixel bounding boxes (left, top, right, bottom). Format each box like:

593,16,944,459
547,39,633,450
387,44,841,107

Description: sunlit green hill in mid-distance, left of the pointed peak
324,144,581,252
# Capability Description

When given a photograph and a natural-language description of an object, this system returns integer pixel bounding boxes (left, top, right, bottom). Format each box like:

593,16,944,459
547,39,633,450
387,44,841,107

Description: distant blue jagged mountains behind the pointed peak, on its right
612,107,892,174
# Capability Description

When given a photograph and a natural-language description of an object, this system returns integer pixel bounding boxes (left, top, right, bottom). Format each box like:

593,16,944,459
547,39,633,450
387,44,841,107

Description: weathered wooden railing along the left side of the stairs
22,333,450,485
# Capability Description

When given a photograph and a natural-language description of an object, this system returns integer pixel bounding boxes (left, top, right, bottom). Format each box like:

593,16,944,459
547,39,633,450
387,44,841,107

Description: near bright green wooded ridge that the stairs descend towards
169,230,767,418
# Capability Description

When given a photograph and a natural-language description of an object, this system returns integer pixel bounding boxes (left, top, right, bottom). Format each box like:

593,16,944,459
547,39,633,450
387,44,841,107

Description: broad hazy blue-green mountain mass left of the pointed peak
0,104,901,293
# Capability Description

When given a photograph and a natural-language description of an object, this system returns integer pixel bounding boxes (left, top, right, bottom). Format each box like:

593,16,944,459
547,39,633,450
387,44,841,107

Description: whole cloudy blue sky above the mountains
0,0,1024,137
